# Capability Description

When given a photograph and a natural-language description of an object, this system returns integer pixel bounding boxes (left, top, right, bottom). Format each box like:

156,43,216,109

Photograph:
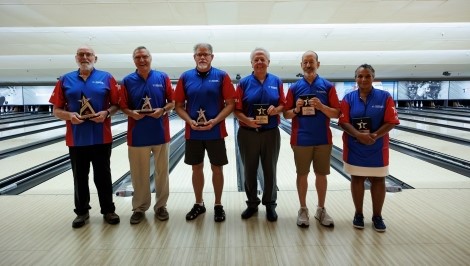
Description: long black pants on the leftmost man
69,144,116,215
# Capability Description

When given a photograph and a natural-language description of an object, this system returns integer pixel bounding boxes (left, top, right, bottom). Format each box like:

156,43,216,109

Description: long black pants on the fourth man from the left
237,127,281,208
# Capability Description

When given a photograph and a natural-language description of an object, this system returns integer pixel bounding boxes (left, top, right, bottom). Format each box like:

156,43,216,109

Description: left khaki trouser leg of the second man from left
127,146,151,212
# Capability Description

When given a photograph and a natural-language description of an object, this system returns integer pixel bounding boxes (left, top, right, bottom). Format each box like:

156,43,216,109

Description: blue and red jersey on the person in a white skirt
338,88,400,167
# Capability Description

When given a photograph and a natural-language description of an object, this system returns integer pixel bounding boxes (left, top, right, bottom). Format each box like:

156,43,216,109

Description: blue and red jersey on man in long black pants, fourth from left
235,73,286,129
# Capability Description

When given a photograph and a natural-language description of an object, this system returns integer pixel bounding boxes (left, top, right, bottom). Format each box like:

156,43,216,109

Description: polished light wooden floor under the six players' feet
0,189,470,265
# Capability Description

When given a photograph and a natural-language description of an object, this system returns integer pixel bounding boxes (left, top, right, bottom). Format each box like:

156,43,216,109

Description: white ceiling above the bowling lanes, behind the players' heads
0,0,470,84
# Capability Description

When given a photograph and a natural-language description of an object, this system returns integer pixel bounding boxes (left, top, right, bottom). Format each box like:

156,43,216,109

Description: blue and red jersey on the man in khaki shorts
285,75,340,146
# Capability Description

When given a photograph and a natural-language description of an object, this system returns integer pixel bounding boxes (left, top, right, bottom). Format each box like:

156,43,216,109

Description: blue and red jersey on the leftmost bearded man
49,69,119,146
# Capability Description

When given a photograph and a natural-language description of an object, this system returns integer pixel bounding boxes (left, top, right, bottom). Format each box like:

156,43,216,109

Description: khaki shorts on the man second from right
291,144,333,175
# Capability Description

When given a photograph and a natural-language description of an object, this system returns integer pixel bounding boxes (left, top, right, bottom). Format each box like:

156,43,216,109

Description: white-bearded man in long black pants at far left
49,46,120,228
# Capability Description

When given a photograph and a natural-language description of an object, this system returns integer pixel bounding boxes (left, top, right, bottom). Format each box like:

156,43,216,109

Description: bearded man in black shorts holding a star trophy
174,43,235,222
